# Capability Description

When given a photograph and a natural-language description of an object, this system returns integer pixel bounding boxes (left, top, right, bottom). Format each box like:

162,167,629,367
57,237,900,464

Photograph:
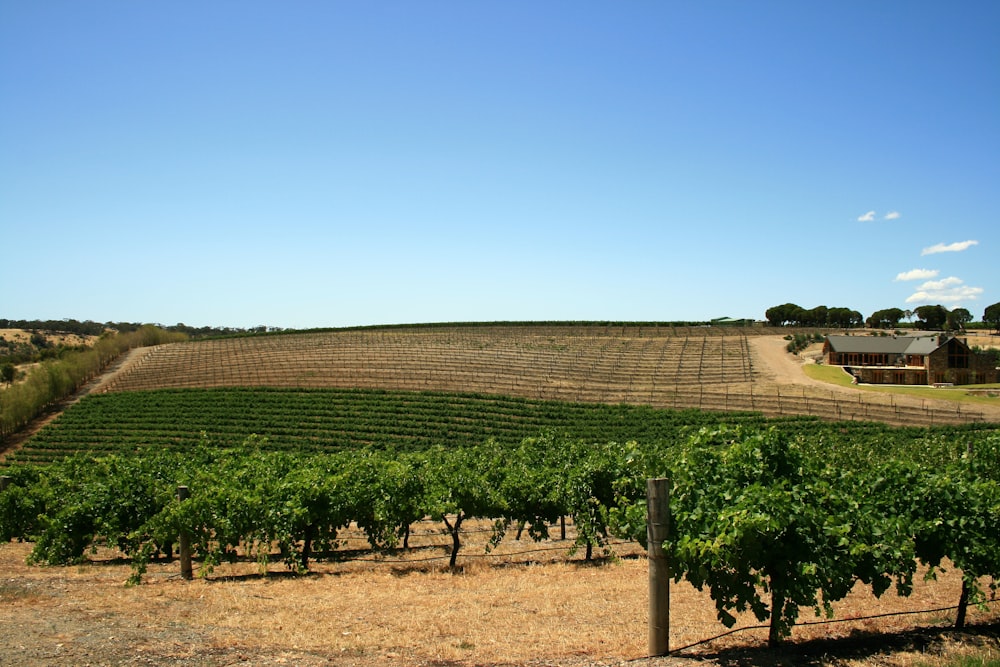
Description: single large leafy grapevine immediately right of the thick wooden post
667,431,880,643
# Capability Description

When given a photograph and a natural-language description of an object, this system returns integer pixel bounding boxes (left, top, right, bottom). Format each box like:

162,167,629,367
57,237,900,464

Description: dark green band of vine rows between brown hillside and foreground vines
9,388,997,466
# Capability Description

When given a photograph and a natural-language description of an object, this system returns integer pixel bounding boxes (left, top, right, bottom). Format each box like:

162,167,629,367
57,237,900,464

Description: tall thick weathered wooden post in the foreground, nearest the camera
646,478,670,656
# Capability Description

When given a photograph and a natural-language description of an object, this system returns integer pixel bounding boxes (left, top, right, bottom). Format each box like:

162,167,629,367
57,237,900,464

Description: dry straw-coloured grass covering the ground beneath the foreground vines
0,529,1000,667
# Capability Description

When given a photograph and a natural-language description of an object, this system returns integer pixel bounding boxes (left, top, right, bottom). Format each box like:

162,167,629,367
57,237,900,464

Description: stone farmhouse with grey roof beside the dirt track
823,333,1000,385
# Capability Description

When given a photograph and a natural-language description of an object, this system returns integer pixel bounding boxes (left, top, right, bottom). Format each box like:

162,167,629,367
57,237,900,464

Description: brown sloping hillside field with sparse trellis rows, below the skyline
97,326,989,425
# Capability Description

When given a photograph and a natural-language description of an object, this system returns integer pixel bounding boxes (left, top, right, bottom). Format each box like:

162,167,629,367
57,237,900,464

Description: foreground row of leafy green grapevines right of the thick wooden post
612,428,1000,644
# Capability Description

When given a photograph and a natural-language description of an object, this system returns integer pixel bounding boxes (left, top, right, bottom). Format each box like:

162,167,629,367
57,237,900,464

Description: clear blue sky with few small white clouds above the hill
0,0,1000,328
